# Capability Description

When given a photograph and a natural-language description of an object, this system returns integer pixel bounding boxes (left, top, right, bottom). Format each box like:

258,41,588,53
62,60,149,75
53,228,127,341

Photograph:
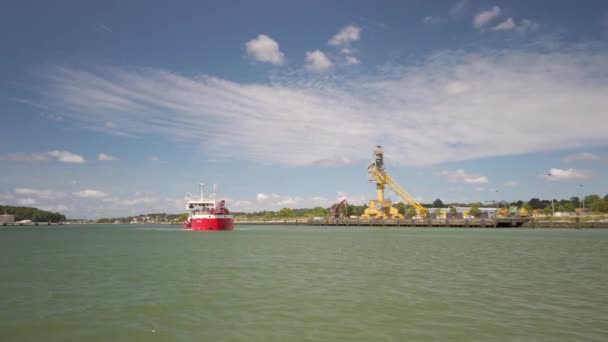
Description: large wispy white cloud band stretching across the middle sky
35,45,608,165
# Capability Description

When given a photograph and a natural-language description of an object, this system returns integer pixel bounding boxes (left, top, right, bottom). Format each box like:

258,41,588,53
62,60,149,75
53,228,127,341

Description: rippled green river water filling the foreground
0,225,608,341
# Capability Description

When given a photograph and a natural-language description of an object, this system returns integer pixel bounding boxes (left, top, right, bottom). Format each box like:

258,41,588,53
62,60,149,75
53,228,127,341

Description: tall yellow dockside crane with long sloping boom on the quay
361,145,428,219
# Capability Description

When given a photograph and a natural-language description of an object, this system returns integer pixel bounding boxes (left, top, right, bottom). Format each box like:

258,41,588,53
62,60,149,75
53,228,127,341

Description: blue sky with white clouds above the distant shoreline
0,0,608,218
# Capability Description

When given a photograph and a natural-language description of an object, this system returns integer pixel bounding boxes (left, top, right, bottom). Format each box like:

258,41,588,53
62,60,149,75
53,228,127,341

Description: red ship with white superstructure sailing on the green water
184,184,234,230
